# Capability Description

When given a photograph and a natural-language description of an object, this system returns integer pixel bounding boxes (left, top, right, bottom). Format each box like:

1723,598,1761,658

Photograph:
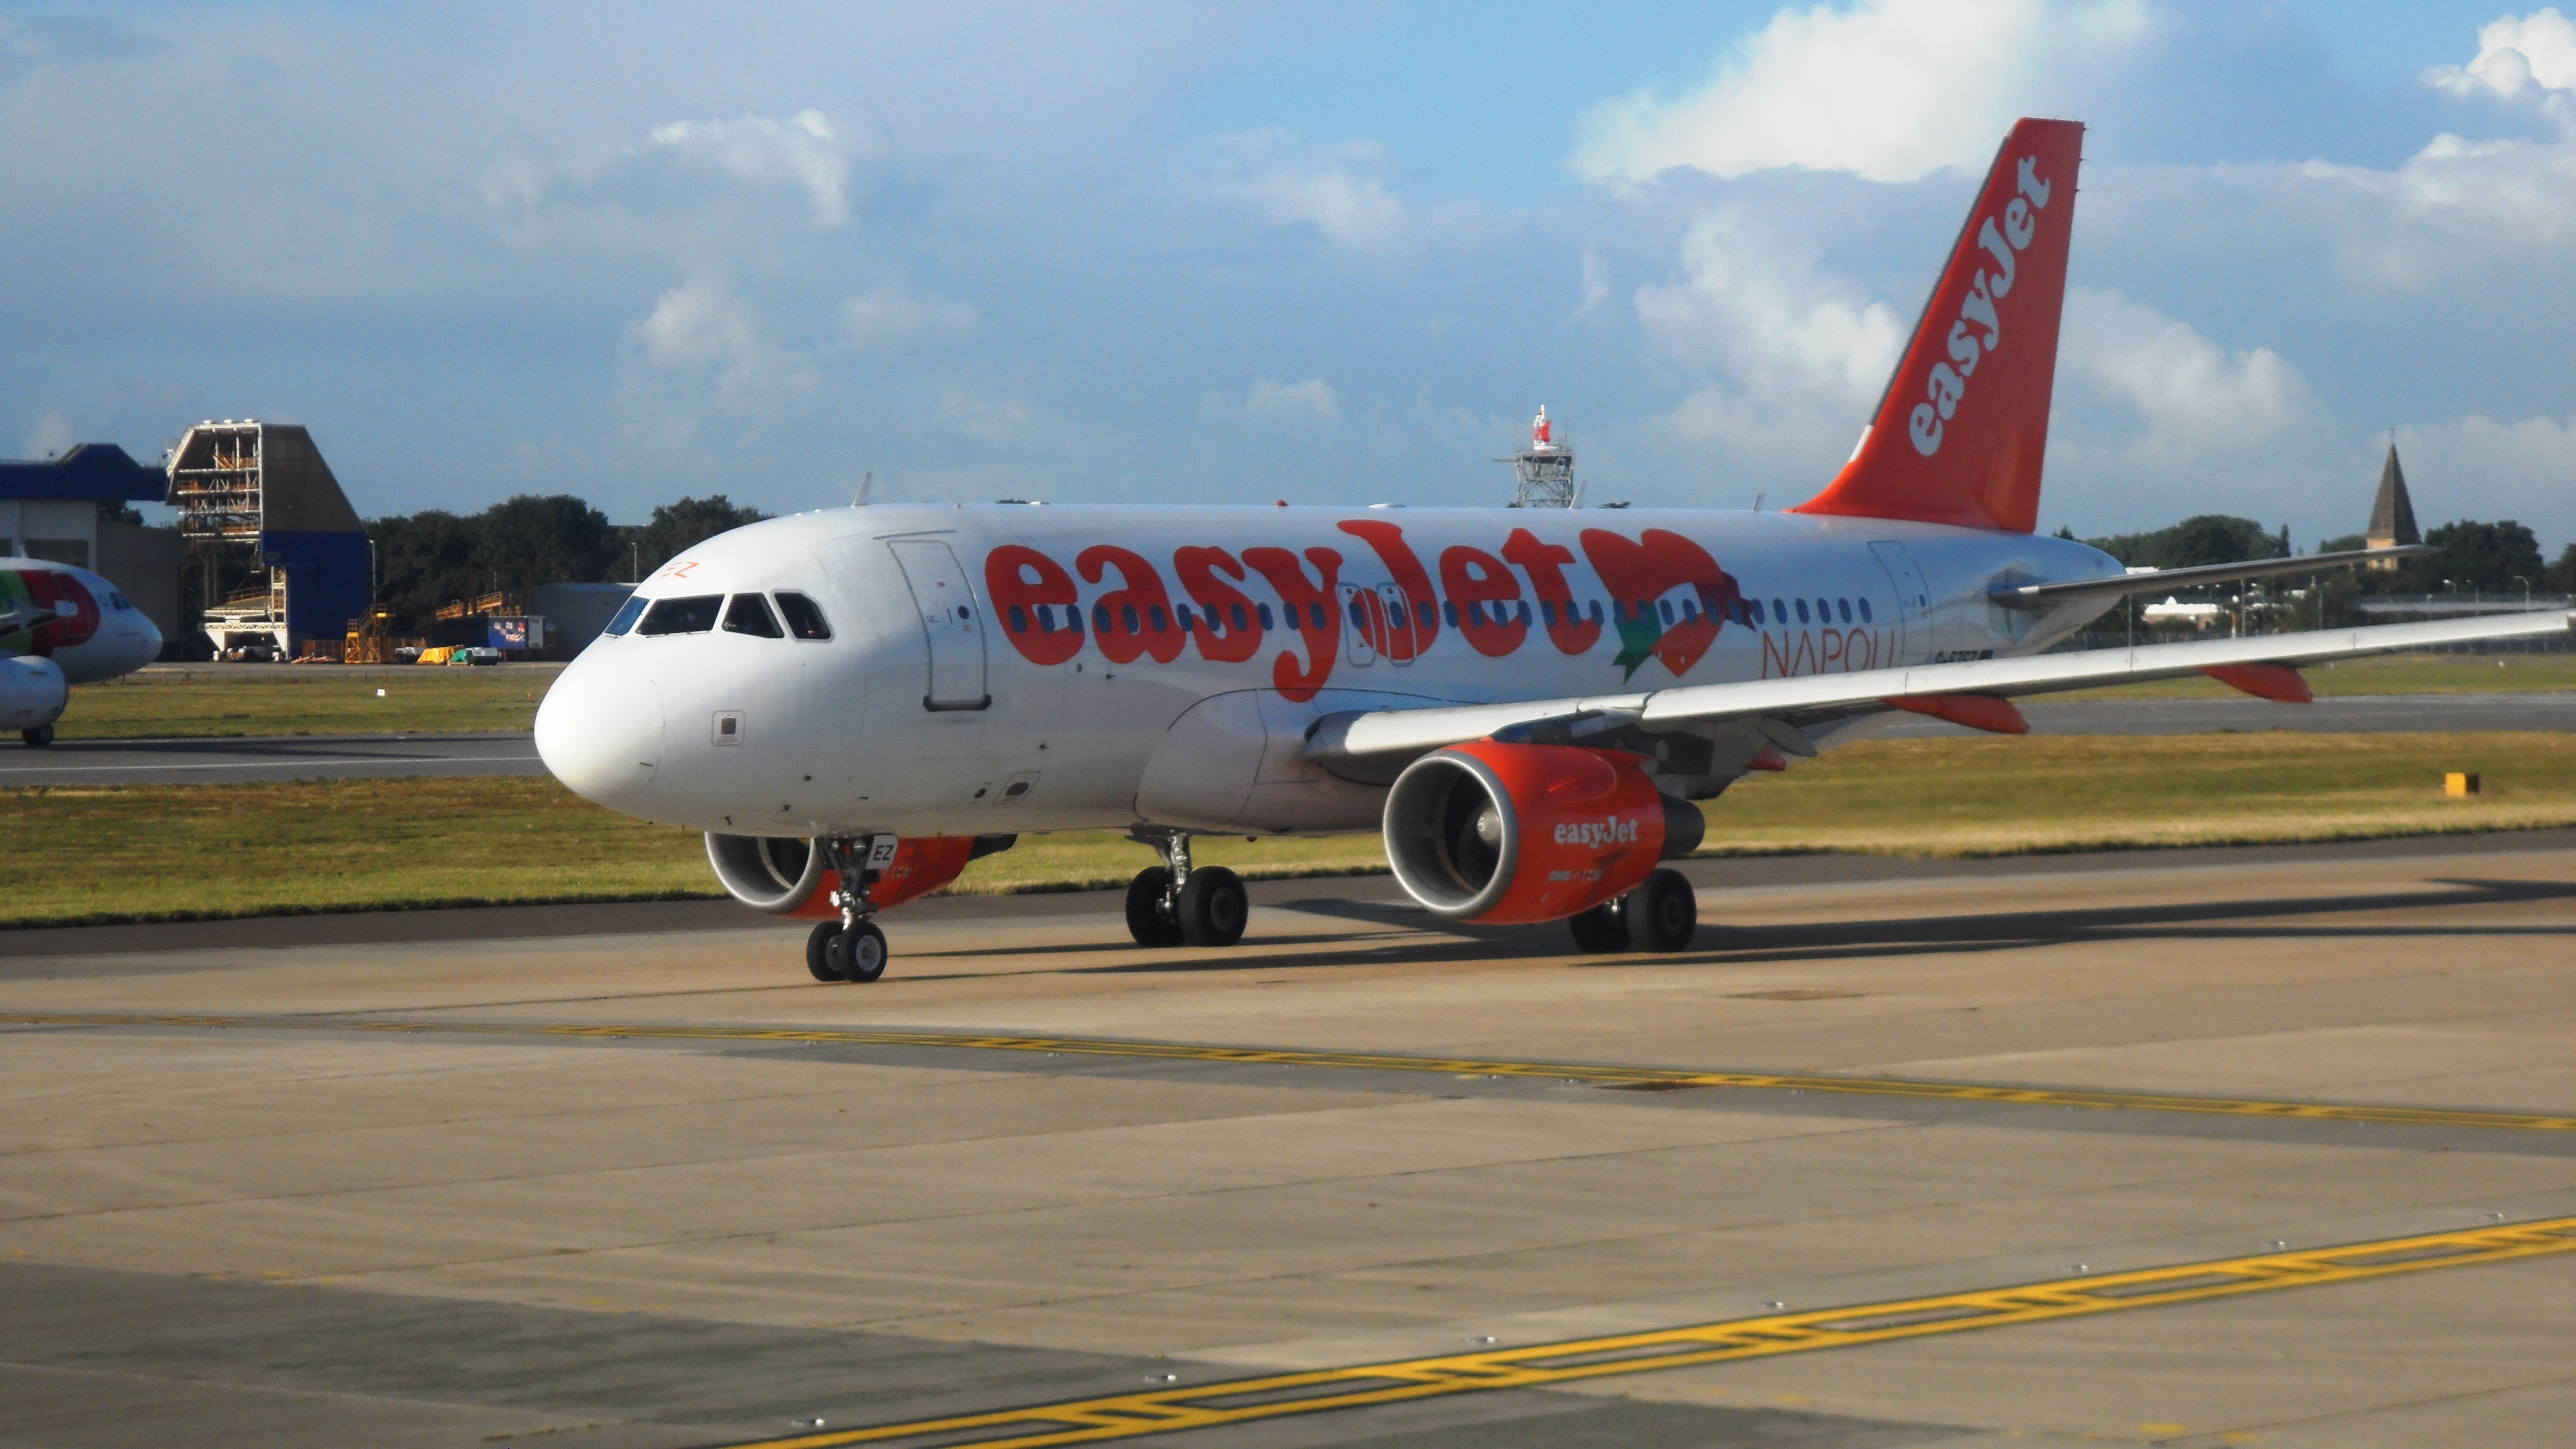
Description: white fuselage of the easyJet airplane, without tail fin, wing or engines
538,505,2120,835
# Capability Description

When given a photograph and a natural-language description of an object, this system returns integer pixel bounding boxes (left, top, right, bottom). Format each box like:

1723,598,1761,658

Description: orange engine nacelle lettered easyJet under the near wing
1386,740,1705,926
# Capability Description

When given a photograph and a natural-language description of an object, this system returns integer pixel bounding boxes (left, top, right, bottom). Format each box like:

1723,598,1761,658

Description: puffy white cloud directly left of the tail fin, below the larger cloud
1636,211,1903,464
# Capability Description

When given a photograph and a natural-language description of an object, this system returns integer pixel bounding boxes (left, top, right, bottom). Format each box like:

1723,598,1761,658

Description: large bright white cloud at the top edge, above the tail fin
1571,0,2146,186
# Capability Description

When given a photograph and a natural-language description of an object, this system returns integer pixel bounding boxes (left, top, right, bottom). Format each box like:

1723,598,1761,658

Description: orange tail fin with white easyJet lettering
1796,121,2084,534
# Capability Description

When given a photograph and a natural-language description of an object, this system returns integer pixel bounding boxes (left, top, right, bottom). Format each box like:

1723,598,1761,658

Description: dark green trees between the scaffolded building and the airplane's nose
366,493,768,634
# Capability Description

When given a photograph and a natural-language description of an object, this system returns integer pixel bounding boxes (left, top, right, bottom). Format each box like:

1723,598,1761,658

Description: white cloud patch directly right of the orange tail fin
2058,286,2310,462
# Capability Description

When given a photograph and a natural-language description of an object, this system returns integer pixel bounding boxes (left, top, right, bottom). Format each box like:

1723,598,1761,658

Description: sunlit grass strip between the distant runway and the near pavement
0,732,2576,926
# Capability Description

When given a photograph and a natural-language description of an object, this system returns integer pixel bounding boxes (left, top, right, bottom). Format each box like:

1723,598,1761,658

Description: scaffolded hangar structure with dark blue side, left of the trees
162,418,371,650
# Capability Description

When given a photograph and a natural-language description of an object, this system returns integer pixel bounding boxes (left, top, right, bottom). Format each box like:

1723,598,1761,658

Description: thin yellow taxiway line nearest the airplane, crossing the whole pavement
15,1011,2576,1132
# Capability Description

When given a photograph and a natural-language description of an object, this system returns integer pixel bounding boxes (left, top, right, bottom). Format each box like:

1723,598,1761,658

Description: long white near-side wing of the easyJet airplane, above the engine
1306,608,2576,774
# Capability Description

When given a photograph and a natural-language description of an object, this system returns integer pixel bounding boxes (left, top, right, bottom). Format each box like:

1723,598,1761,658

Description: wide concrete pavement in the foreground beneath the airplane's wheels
0,833,2576,1449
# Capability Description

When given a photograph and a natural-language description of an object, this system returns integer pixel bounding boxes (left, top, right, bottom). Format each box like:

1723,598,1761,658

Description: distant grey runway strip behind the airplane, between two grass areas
15,694,2576,789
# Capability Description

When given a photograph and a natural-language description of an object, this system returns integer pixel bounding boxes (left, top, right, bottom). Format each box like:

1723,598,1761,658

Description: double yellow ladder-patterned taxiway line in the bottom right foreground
705,1217,2576,1449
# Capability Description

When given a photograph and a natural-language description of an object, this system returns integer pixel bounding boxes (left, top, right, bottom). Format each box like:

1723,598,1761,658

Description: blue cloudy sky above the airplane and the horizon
0,0,2576,552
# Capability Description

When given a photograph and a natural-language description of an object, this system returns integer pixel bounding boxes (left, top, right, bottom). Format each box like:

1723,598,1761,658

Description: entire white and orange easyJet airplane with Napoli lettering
536,121,2576,982
